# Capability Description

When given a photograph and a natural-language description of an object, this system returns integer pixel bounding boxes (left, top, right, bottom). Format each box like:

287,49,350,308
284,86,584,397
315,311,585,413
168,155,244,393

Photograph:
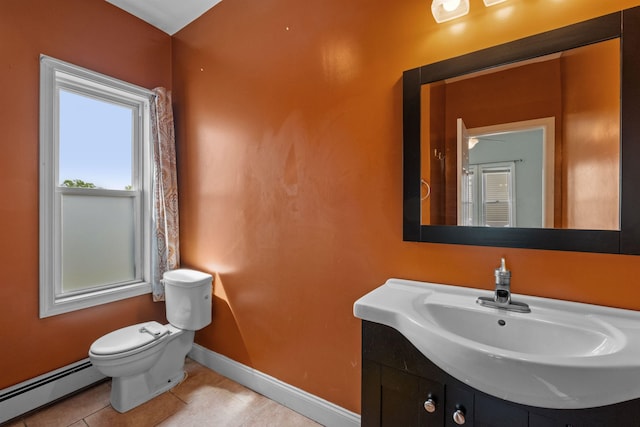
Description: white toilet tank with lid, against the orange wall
162,268,212,331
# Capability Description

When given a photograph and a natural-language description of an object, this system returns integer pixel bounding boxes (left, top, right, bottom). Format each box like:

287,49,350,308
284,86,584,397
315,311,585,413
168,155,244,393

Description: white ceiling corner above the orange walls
106,0,222,35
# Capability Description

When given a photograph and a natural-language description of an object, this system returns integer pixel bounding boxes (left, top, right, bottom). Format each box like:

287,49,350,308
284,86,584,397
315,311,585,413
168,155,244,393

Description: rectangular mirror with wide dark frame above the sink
403,7,640,254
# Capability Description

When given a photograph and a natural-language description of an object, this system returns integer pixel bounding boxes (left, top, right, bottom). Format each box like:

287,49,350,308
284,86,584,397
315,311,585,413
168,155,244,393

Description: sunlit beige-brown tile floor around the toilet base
6,359,320,427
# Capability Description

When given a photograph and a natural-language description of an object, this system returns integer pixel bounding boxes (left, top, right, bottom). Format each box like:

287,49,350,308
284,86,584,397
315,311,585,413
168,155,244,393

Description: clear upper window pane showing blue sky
59,90,133,190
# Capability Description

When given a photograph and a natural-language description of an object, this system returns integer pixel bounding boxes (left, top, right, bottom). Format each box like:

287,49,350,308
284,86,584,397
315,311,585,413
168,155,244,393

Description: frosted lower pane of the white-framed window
62,195,135,292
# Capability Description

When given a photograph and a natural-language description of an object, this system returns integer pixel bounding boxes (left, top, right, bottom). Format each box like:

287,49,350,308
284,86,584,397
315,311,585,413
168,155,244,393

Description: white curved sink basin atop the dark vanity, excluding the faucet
354,279,640,409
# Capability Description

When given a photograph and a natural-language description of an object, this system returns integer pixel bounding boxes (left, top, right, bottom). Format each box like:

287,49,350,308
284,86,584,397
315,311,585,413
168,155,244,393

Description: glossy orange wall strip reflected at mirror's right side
562,40,620,230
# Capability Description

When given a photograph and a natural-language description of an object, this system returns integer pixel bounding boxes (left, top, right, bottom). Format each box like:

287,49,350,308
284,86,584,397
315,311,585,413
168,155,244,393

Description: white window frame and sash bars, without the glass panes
40,55,153,318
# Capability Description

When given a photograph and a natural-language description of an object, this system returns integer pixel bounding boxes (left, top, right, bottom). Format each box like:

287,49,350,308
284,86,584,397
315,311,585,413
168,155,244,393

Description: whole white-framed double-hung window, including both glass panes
40,56,152,317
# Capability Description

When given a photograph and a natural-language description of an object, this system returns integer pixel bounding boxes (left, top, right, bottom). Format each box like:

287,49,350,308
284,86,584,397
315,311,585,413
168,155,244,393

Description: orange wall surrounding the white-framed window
0,0,171,389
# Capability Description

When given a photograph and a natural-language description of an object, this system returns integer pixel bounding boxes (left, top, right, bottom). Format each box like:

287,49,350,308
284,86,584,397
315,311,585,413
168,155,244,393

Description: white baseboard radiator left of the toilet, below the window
0,358,105,424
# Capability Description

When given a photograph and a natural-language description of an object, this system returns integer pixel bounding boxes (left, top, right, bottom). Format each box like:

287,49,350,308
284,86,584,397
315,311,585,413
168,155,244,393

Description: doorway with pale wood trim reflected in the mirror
458,117,555,228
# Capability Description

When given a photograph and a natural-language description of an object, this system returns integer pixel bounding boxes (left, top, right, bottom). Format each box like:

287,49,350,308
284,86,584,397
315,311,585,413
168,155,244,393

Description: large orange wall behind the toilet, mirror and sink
173,0,640,411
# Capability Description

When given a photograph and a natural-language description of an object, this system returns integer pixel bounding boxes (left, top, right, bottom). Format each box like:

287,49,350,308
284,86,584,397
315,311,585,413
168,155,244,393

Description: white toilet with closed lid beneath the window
89,269,212,412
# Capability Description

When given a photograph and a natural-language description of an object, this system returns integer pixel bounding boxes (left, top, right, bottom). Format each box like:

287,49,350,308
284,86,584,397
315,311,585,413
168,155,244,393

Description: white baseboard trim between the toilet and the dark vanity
189,344,360,427
